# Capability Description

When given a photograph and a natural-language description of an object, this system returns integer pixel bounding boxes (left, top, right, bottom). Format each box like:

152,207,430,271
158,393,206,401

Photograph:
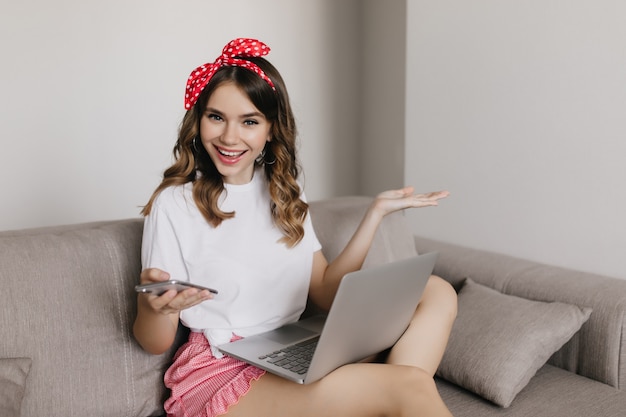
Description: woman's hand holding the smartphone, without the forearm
139,268,213,315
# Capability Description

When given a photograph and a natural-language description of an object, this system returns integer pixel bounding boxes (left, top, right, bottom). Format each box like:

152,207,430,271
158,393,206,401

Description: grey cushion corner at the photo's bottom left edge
0,358,32,417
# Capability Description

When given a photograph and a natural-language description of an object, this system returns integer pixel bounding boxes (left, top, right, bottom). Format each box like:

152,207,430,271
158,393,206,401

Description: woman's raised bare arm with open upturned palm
309,187,449,310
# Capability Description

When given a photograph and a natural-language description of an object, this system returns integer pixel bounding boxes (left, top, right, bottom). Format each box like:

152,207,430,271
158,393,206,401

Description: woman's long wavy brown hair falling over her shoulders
141,58,308,247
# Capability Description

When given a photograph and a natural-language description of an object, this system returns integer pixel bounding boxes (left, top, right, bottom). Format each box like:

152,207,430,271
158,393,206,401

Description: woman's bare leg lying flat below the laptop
227,363,451,417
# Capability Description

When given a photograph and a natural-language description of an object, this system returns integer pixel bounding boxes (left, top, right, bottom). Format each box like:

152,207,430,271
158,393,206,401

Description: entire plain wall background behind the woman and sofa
0,0,626,278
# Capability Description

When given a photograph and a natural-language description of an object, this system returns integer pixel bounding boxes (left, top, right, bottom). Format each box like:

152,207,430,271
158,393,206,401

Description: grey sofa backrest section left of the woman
0,219,171,417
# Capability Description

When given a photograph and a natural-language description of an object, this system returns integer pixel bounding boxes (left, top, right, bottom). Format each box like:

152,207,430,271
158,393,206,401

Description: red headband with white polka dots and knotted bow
185,38,276,110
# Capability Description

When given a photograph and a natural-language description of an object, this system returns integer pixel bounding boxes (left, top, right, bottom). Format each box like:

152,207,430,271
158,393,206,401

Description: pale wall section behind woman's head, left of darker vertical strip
0,0,357,230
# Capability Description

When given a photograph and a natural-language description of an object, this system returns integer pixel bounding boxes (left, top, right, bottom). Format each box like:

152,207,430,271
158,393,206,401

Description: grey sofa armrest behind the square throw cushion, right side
414,236,626,389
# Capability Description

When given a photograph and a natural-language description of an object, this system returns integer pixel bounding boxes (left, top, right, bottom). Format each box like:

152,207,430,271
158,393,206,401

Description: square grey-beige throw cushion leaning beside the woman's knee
437,278,591,407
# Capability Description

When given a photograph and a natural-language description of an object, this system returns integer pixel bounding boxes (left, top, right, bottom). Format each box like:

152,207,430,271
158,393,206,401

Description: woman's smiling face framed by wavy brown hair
200,82,271,184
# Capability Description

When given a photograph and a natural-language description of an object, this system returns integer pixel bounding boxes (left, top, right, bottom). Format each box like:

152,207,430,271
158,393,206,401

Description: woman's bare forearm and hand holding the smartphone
133,269,213,355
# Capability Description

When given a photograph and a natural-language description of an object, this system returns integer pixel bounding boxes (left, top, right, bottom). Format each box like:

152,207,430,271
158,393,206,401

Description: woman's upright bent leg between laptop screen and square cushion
386,276,457,377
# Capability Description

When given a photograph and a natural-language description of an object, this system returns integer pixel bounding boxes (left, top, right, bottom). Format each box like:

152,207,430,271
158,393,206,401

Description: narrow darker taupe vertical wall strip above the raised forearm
357,0,406,196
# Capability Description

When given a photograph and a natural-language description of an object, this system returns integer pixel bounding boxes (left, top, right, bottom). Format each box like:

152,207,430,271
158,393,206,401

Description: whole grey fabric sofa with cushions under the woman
0,197,626,417
